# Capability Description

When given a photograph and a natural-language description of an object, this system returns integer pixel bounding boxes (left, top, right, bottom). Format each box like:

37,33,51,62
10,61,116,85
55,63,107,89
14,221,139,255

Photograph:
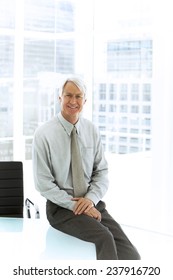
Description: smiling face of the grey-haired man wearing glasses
59,82,86,124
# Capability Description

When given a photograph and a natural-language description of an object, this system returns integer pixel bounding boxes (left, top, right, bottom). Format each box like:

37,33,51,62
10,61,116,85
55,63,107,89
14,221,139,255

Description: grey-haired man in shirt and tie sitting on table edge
33,77,140,260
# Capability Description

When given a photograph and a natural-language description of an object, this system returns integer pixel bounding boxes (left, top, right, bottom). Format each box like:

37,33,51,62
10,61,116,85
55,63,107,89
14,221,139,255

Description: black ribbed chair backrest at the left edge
0,161,24,218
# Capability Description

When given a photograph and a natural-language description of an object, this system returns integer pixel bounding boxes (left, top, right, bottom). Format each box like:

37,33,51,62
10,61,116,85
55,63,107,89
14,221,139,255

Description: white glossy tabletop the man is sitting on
0,218,96,261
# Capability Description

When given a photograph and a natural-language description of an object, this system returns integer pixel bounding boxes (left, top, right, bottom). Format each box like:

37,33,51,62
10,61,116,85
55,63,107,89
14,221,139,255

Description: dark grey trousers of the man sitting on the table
46,200,140,260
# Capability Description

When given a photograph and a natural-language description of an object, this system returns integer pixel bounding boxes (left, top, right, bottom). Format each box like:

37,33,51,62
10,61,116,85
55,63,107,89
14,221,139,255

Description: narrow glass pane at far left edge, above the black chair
0,0,15,160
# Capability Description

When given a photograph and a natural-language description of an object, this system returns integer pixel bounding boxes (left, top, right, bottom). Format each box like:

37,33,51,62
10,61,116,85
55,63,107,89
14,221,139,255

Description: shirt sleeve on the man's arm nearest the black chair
33,132,75,210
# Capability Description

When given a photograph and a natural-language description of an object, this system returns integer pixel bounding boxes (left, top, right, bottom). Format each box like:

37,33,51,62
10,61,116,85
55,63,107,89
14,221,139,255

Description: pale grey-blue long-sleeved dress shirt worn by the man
33,113,108,210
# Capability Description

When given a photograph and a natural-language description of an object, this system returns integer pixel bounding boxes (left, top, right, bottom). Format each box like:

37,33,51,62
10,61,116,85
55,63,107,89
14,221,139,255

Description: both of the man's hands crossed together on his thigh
72,197,101,222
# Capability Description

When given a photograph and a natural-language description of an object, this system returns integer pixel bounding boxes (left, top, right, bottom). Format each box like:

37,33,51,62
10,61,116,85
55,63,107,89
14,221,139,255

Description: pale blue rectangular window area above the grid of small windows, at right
107,40,152,77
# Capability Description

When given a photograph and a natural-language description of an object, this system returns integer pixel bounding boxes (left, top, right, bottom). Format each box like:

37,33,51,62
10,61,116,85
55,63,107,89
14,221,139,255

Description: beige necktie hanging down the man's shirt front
71,126,86,197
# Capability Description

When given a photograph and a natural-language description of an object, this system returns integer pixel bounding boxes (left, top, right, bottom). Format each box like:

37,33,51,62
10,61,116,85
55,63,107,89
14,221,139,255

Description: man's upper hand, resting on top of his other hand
72,197,94,215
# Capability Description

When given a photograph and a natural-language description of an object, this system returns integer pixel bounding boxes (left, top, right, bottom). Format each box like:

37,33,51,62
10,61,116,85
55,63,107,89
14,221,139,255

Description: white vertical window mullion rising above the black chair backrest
13,0,25,160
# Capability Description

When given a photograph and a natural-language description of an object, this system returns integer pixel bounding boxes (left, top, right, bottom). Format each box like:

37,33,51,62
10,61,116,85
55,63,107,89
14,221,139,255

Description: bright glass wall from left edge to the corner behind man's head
0,0,93,160
